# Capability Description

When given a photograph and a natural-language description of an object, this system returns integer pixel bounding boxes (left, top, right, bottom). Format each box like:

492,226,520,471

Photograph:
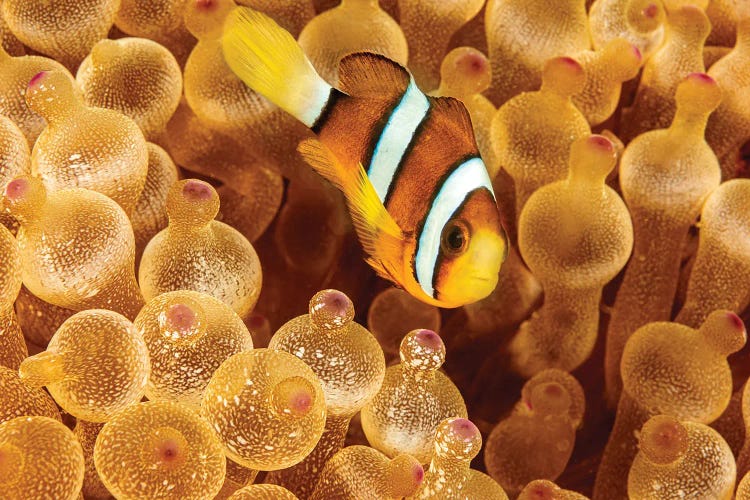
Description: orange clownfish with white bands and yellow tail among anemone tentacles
222,8,508,307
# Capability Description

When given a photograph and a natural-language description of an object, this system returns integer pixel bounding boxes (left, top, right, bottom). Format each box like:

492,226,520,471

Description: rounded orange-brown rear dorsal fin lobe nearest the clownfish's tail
339,52,411,99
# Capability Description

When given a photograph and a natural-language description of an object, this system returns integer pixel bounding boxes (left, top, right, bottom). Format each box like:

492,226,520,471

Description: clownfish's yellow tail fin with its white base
222,7,331,127
